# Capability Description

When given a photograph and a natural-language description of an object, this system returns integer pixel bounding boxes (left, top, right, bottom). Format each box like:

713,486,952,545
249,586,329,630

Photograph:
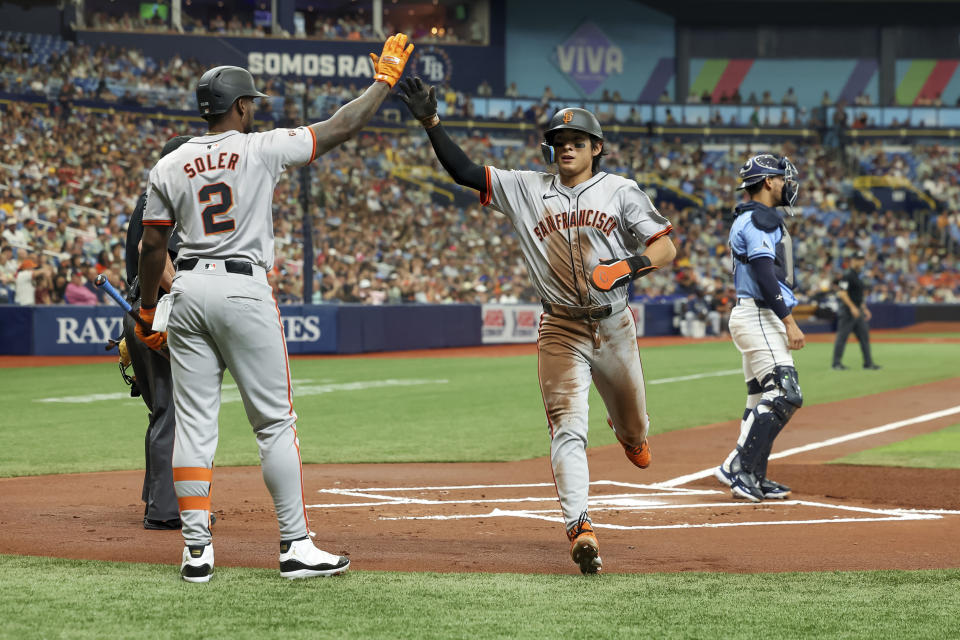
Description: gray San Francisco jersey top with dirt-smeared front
481,167,672,307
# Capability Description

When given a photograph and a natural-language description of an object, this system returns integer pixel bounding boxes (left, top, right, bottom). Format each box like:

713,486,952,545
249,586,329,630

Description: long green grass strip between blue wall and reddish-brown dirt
0,342,960,477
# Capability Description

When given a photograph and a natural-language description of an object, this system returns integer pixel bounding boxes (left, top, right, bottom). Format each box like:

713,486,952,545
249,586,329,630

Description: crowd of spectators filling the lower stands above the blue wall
0,97,960,308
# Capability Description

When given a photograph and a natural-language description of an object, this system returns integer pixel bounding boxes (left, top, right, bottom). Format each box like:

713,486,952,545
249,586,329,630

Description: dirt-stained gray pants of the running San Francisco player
537,307,649,530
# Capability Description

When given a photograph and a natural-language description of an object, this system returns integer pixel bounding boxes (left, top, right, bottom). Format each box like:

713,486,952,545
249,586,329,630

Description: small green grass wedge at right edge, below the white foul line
833,424,960,469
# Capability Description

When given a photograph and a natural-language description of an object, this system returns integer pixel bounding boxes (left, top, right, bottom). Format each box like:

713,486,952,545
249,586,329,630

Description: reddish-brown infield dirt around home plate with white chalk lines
0,378,960,573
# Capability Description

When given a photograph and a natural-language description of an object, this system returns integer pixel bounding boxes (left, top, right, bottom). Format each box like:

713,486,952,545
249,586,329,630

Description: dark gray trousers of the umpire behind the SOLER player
123,315,179,520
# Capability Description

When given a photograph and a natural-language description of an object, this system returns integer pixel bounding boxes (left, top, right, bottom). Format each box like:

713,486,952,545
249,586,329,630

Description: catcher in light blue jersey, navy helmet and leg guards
714,154,804,502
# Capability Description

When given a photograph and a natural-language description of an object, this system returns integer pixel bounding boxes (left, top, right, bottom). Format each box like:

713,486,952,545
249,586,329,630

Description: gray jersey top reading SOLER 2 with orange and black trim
143,127,317,270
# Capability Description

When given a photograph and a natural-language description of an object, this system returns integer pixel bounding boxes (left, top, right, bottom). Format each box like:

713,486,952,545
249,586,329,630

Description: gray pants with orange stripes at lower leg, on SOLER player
168,259,308,545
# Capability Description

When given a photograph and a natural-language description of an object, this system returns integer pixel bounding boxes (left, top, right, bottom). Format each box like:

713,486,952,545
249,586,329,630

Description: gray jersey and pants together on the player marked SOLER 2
143,127,317,545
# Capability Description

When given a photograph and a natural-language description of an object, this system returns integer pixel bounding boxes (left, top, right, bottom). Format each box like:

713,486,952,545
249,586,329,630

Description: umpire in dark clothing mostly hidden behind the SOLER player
123,136,190,529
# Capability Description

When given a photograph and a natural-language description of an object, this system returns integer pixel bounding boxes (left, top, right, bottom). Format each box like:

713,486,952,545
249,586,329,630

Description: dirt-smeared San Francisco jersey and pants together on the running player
480,167,672,535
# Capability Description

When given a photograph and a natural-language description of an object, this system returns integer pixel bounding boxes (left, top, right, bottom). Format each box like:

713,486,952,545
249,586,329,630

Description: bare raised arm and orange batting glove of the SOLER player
310,33,413,155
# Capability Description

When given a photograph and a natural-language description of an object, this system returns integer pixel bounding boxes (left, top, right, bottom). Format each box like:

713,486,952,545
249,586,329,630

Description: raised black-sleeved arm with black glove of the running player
397,78,486,191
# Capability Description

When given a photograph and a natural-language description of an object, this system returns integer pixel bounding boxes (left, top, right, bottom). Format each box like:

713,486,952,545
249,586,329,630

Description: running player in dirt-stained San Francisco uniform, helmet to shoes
399,78,676,573
